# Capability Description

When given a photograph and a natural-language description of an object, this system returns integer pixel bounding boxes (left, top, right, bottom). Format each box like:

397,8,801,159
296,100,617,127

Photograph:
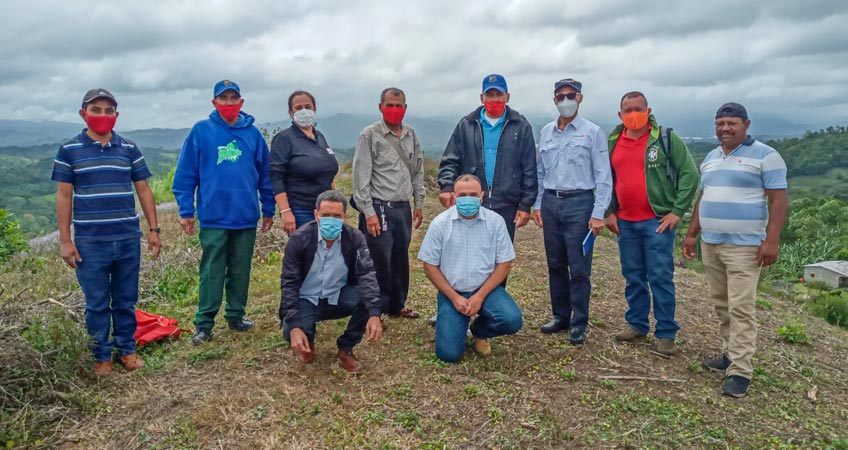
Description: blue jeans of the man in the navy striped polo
76,238,141,361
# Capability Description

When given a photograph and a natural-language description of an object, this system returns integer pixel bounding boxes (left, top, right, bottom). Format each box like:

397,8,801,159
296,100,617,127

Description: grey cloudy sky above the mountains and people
0,0,848,134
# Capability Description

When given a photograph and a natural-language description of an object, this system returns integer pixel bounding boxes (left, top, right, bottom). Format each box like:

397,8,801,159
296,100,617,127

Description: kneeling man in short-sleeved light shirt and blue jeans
418,175,523,362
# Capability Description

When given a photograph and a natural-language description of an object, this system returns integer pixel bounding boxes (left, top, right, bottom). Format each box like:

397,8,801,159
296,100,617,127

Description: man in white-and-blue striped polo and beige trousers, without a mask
683,103,789,398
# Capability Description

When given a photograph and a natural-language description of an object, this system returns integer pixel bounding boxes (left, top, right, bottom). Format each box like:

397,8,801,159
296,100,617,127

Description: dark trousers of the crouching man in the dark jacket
283,285,368,351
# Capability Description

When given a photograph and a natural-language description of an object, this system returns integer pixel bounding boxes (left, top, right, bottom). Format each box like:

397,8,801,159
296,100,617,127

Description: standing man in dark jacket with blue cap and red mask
439,74,538,239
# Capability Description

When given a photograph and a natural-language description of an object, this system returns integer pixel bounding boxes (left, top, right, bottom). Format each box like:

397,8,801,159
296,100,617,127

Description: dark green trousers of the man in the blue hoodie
194,228,256,330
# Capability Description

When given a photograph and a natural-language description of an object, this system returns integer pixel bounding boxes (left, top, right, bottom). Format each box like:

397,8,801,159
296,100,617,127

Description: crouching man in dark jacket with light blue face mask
280,191,383,373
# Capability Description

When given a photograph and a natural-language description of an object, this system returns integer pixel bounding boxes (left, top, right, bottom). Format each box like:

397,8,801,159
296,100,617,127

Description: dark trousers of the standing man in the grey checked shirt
359,200,412,315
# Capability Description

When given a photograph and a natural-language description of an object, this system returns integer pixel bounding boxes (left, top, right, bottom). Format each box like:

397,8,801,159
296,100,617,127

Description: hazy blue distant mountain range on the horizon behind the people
0,114,810,158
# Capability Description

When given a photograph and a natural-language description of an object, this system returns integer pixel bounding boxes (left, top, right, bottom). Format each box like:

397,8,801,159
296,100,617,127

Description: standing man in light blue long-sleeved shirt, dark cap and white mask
533,78,612,345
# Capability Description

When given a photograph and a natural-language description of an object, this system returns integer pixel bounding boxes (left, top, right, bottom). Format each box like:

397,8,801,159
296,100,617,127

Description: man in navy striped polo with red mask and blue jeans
52,89,161,375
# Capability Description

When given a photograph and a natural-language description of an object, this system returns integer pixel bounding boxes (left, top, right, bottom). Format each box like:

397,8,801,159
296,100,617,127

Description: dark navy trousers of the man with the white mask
542,191,595,329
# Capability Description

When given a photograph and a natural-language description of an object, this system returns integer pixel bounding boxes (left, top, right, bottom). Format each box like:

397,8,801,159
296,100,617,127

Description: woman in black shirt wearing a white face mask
270,91,339,234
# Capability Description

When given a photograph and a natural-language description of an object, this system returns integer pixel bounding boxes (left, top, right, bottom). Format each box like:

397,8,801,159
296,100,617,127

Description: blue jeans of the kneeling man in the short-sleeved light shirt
436,286,524,362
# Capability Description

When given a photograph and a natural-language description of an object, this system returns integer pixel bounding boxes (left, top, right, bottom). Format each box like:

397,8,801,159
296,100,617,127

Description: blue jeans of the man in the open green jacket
618,218,680,339
